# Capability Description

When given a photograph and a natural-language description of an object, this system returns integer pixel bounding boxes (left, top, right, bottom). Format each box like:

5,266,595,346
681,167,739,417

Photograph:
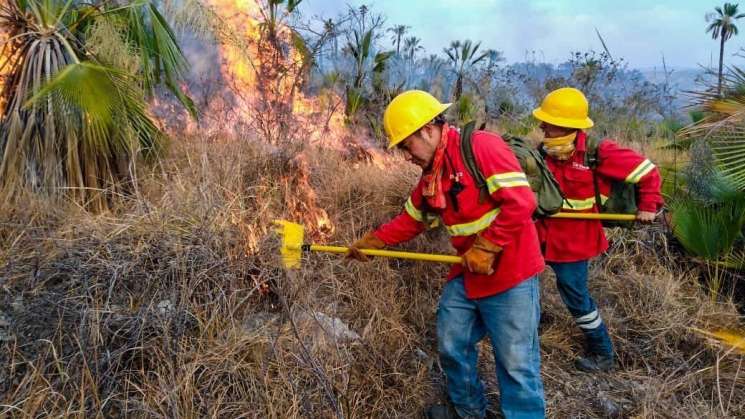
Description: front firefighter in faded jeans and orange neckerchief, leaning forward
349,90,545,418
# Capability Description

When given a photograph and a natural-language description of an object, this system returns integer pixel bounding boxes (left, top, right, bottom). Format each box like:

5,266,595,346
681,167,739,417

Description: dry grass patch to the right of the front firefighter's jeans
543,227,745,418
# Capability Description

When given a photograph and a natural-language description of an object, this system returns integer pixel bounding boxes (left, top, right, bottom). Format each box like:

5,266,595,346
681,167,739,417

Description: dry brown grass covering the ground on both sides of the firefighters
0,134,745,418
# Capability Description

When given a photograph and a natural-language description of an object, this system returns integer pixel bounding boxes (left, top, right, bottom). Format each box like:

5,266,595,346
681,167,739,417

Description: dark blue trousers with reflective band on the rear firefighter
549,260,613,356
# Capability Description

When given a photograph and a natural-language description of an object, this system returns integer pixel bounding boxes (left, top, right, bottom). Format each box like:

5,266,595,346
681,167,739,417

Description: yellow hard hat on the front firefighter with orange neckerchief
383,90,451,149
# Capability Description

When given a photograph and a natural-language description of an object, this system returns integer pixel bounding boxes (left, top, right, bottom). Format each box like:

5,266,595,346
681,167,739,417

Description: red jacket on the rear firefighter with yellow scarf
538,132,663,262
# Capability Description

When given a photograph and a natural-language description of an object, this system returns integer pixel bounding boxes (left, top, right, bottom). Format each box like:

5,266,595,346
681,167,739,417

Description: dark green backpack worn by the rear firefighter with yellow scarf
585,137,639,227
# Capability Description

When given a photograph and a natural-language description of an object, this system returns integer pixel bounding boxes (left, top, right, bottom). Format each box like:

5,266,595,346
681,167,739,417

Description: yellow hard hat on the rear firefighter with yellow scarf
533,87,594,129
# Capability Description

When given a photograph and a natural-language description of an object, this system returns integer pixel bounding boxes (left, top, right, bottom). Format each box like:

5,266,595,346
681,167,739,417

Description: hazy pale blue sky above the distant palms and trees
302,0,745,68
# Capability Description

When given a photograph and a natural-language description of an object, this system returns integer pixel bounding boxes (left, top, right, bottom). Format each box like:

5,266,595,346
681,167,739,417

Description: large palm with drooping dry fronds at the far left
0,0,196,210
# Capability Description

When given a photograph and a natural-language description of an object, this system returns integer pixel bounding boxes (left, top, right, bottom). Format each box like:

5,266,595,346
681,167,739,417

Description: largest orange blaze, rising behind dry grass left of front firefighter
195,0,390,168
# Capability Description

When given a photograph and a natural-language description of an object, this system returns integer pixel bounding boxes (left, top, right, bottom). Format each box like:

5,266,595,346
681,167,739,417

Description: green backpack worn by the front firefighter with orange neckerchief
460,122,564,217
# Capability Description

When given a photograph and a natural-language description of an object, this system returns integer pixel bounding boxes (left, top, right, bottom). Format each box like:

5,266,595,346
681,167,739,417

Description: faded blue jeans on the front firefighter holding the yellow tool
437,276,545,419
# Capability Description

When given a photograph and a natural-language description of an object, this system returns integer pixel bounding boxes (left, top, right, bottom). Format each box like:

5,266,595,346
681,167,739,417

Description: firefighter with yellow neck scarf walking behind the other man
533,87,663,372
